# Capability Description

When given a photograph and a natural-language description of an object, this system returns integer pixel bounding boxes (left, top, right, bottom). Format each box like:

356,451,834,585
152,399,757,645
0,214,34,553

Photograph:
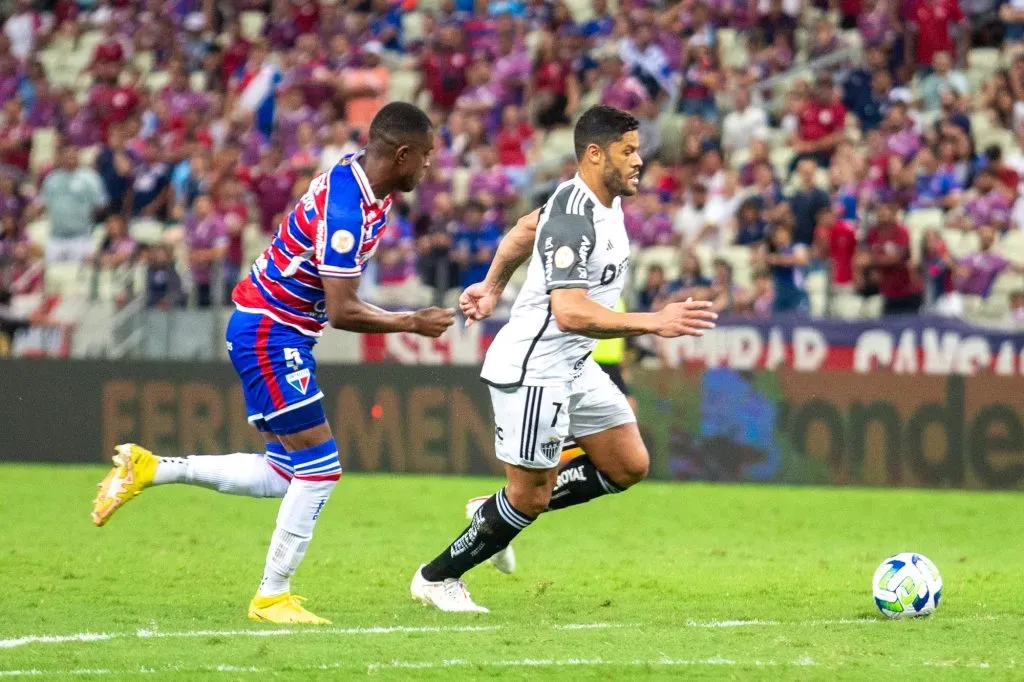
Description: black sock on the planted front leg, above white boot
423,487,534,583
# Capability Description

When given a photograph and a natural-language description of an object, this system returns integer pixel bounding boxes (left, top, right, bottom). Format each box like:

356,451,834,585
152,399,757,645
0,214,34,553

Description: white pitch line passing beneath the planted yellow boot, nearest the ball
0,615,1010,649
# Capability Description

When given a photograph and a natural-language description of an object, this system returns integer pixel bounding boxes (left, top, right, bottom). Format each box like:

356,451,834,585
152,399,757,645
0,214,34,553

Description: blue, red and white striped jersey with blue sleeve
231,153,391,336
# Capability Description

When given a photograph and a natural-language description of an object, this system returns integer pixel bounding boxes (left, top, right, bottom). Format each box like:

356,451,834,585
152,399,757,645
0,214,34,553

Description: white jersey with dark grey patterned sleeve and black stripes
480,175,630,388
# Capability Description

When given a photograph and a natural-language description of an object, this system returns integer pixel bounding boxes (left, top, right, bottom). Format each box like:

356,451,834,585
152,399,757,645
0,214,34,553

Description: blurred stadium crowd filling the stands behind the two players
0,0,1024,350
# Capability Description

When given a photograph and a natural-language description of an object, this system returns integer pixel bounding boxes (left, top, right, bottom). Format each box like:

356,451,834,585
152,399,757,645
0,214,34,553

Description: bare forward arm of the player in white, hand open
551,288,718,339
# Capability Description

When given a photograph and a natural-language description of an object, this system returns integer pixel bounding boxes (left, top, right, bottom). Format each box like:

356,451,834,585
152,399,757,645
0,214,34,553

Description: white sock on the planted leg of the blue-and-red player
259,478,338,597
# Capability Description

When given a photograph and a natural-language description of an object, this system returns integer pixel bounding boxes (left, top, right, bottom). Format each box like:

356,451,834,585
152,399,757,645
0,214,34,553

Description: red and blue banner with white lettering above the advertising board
358,316,1024,377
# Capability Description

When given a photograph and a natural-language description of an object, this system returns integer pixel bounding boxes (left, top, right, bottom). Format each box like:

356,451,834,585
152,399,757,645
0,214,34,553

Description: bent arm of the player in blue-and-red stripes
324,278,455,338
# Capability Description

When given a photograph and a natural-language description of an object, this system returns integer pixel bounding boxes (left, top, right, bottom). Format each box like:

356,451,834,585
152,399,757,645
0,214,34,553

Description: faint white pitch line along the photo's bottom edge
0,654,1018,678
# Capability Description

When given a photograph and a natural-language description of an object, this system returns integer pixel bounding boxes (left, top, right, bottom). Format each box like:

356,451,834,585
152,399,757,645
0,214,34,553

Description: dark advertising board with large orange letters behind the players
0,360,1024,488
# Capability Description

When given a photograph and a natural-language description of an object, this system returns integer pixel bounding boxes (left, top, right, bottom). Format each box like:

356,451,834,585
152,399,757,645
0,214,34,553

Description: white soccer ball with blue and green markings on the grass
871,552,942,619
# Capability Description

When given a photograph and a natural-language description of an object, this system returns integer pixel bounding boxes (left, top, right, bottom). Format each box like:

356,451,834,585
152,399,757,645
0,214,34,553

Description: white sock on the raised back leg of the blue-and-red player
153,453,289,498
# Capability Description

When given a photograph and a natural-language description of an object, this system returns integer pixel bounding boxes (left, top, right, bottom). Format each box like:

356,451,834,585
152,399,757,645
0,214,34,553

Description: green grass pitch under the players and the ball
0,465,1024,681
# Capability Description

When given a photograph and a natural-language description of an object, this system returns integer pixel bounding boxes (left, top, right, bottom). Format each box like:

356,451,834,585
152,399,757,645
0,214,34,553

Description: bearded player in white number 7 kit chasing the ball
411,105,716,611
